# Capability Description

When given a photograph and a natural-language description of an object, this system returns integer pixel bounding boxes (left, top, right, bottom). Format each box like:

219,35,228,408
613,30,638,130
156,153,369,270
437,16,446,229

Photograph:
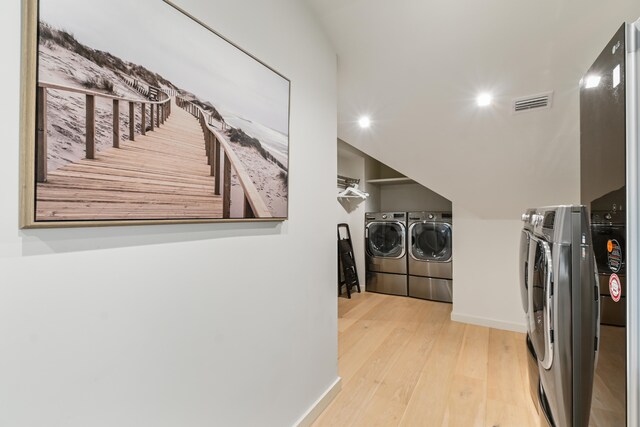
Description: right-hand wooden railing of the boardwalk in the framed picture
176,97,272,218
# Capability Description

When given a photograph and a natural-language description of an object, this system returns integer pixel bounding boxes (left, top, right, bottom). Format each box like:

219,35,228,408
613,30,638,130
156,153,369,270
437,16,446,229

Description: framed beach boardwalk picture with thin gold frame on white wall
20,0,291,228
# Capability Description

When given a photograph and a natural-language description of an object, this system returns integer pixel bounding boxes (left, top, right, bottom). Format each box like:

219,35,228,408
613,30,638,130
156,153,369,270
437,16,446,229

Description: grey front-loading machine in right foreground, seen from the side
520,206,599,427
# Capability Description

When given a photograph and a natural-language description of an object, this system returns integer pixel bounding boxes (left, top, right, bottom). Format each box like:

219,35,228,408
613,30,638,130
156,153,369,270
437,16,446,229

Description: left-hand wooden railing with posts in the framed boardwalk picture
36,82,171,182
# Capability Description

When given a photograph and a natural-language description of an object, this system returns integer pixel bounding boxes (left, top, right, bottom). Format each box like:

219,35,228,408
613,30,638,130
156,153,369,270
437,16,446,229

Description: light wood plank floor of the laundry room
313,293,537,427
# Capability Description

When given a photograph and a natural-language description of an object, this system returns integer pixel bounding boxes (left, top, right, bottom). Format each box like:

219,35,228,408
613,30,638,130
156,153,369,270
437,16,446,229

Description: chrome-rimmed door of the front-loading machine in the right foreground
527,235,554,369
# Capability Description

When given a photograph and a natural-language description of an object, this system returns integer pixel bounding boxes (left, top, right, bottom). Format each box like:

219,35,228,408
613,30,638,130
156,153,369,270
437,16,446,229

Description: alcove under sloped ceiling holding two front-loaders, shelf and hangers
337,140,454,303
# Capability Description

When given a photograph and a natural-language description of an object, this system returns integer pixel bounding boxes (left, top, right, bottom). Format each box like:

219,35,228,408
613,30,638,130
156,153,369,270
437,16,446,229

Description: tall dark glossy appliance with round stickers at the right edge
580,24,638,426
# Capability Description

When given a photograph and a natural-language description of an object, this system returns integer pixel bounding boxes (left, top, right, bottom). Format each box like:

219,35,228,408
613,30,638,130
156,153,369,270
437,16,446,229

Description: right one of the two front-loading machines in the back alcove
407,212,453,302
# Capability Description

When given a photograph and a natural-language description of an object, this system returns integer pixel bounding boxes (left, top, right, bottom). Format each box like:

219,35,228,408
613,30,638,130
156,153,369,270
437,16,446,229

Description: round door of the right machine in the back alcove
410,222,451,262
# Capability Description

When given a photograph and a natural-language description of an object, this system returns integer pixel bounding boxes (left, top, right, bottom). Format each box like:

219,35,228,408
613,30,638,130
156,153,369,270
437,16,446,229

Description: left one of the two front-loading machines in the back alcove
365,212,408,296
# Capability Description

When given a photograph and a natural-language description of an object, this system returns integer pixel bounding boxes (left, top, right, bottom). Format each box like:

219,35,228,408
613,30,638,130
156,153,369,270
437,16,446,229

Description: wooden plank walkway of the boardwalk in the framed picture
36,99,222,221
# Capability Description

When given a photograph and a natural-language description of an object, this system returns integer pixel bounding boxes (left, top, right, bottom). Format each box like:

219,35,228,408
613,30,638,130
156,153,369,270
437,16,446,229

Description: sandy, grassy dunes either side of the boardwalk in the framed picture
38,23,288,217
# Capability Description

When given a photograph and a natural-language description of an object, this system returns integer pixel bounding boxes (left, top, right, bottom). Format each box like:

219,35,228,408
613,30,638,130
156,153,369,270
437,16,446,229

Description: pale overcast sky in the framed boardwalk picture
39,0,289,135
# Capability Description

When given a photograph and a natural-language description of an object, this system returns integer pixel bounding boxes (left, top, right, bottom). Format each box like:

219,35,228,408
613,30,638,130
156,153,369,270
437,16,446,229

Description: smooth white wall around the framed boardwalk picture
0,0,337,427
